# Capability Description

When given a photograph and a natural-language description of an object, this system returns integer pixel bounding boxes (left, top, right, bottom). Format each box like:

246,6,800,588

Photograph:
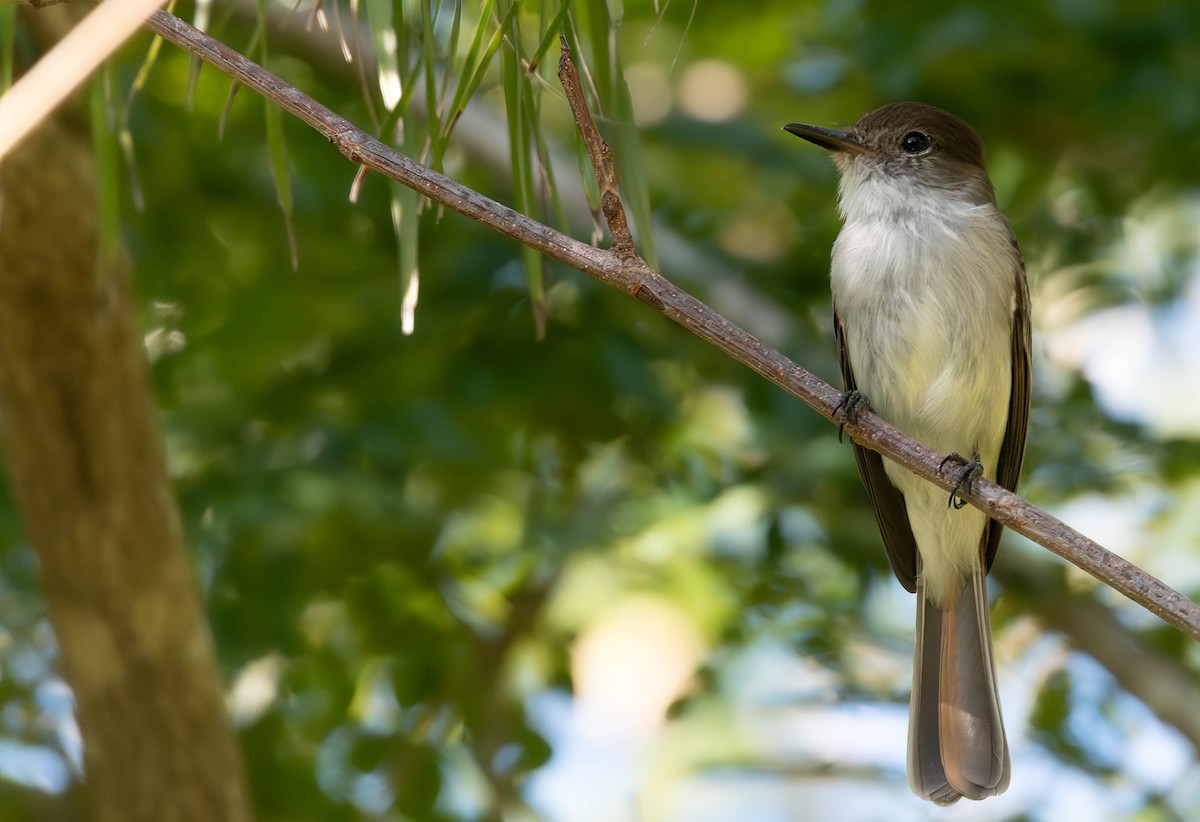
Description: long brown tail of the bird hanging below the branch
908,569,1009,805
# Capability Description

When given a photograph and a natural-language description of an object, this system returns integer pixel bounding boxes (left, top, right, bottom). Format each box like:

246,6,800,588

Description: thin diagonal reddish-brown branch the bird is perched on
146,11,1200,641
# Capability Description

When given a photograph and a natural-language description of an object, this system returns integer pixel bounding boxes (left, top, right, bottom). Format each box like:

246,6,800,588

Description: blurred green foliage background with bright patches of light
0,0,1200,822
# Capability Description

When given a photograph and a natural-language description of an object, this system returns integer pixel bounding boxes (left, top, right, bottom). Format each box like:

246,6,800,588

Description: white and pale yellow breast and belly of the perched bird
830,173,1018,599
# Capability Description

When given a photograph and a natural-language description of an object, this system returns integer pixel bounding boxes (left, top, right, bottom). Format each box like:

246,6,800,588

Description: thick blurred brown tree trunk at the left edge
0,121,251,822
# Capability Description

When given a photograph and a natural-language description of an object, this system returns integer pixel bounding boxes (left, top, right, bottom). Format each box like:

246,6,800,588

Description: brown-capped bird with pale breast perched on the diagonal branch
784,102,1031,805
